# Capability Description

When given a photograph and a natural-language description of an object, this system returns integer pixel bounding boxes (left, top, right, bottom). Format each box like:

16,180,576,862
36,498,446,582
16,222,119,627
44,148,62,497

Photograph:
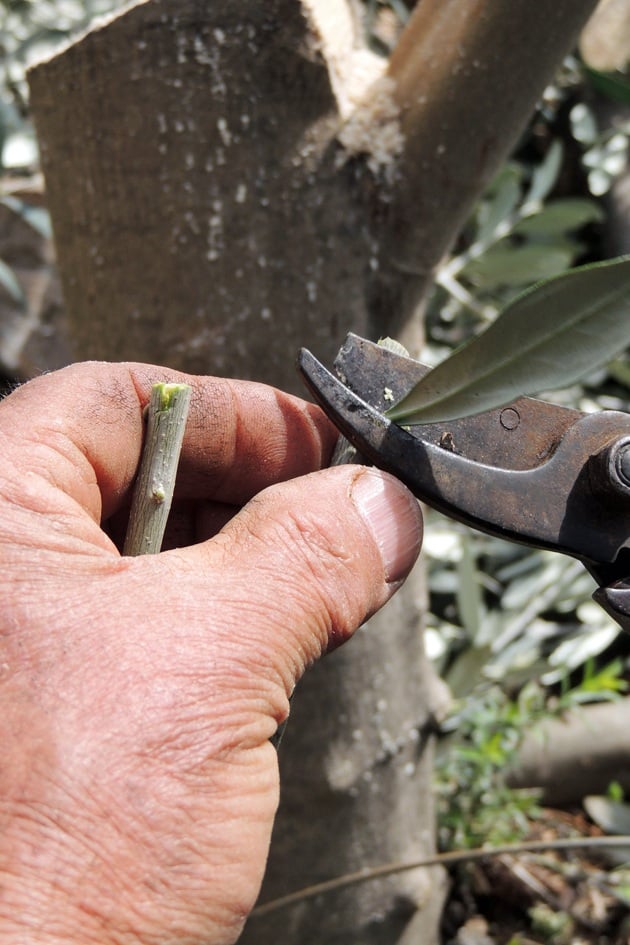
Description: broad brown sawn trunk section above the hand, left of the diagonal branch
29,0,386,390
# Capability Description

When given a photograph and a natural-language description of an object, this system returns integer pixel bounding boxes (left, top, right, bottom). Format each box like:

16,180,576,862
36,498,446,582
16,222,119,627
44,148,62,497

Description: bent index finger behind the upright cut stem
0,362,336,518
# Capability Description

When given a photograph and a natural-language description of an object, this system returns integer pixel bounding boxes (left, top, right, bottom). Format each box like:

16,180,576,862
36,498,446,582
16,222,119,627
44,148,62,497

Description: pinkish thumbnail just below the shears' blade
352,469,422,583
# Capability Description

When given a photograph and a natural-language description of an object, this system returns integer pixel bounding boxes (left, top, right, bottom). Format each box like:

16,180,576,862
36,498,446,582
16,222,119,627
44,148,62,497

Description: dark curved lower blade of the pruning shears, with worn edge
298,350,630,568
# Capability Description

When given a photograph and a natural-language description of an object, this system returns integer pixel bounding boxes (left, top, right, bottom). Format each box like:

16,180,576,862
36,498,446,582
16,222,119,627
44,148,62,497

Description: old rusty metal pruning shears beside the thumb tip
298,334,630,631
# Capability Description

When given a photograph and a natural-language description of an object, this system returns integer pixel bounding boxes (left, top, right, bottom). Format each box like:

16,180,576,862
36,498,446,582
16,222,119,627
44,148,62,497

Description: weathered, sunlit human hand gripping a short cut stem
0,363,421,945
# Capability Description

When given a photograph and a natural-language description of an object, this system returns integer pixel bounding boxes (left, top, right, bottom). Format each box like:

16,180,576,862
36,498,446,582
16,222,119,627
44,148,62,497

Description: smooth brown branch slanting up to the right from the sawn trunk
377,0,597,328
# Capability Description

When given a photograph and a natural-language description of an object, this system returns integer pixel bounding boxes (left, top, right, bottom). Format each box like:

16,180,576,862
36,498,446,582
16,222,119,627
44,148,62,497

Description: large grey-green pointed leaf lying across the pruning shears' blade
388,256,630,423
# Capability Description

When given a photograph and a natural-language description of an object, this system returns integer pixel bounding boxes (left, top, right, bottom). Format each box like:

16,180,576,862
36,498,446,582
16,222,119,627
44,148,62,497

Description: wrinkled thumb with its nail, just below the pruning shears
178,466,422,687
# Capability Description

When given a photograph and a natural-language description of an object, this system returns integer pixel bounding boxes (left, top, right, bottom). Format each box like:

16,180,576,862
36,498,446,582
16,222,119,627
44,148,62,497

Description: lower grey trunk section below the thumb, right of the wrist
242,572,454,945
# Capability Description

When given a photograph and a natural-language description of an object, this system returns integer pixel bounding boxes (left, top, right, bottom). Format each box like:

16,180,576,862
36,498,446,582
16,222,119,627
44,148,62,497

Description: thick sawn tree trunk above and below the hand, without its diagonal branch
30,0,443,945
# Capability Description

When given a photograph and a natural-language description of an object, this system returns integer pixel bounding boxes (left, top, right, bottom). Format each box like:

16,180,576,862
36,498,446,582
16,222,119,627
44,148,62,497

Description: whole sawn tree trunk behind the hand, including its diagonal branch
30,0,595,945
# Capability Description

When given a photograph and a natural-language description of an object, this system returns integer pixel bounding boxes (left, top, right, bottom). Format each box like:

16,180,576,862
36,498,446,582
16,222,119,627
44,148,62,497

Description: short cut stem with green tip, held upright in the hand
123,383,192,555
